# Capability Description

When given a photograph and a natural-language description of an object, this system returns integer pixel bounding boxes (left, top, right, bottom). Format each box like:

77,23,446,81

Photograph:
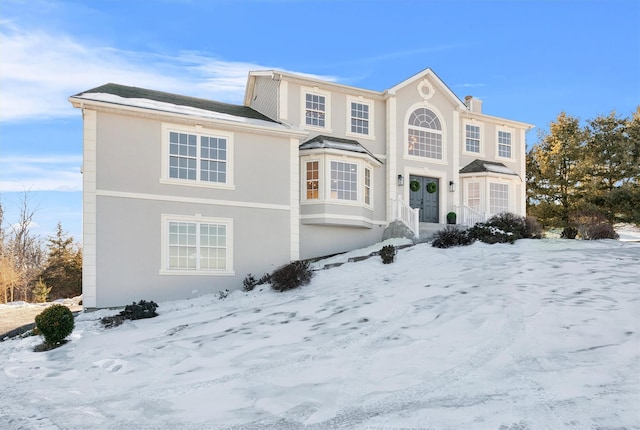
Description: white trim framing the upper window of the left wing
159,123,236,190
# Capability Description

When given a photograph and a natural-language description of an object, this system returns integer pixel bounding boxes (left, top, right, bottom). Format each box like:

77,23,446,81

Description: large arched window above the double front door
408,108,442,160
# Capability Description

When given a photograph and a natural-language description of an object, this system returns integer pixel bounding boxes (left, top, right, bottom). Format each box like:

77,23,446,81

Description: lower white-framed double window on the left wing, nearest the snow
164,220,230,271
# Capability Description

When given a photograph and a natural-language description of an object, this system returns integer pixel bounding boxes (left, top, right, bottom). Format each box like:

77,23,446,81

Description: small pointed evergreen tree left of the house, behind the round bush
41,223,82,300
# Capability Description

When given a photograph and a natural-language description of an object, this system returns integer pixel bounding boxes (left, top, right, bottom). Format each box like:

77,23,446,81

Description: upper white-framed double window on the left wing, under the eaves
161,125,232,191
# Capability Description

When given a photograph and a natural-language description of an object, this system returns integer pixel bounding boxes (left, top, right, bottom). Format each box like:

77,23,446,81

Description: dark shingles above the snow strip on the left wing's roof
75,83,277,123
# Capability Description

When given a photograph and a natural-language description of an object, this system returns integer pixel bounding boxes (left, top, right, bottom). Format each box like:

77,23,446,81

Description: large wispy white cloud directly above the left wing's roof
0,20,335,121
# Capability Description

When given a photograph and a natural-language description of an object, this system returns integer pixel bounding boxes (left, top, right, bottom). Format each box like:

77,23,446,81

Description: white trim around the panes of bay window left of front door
300,154,375,209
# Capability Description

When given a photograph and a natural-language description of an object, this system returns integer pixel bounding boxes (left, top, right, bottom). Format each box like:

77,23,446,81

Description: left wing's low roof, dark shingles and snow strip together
72,83,285,127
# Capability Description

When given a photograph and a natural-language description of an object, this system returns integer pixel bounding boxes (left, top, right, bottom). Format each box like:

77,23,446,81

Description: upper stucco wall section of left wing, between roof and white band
97,113,291,205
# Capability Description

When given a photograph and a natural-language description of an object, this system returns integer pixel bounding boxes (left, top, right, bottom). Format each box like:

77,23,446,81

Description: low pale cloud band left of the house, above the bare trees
0,155,82,192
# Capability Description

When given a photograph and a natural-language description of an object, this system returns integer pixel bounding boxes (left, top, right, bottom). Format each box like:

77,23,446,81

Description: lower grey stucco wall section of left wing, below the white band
96,196,290,307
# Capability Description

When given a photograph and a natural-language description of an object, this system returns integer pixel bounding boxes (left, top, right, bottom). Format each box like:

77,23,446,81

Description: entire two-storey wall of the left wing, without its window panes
83,109,300,308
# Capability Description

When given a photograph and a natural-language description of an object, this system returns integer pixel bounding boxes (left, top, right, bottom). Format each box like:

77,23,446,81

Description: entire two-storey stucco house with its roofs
69,69,532,308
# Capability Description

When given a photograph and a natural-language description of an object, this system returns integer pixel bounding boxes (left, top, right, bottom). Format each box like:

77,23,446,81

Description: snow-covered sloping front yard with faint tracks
0,239,640,430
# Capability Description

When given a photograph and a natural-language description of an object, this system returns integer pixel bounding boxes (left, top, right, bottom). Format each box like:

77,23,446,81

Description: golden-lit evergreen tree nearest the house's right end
527,112,585,227
